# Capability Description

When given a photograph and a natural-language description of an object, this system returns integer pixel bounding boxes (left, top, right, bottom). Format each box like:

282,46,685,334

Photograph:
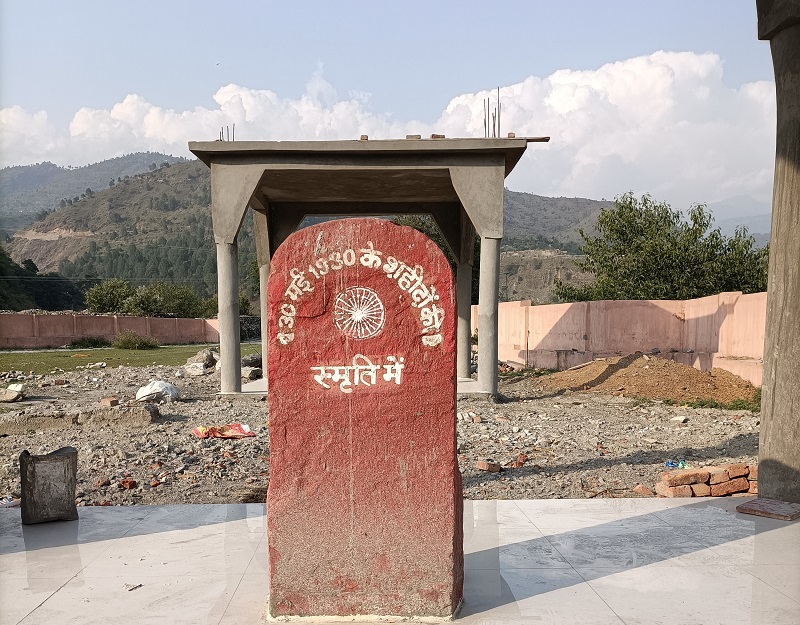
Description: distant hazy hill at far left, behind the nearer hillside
0,152,186,239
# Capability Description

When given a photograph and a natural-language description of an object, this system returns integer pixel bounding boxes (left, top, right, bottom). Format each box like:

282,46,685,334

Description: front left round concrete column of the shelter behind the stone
217,241,242,393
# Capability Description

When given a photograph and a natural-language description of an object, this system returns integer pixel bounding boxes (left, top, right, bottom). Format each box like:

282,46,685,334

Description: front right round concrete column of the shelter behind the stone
478,237,500,395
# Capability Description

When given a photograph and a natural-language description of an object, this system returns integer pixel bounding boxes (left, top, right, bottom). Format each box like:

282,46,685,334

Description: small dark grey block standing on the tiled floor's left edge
19,447,78,525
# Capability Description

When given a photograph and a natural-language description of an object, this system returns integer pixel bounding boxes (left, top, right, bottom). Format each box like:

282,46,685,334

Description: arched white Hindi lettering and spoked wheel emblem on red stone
277,241,444,347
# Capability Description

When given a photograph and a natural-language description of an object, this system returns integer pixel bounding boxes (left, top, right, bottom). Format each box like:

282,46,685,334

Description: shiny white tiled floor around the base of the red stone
0,498,800,625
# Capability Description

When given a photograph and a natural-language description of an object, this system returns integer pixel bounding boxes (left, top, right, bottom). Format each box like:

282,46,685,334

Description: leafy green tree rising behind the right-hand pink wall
553,193,769,301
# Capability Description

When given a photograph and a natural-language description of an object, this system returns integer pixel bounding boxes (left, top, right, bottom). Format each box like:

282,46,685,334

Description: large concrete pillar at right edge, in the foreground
757,0,800,503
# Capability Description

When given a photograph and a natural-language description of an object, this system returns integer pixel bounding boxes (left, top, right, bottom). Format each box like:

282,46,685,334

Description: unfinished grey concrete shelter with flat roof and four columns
189,137,549,395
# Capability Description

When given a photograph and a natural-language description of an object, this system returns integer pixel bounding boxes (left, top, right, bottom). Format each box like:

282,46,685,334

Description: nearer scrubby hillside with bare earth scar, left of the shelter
8,161,255,297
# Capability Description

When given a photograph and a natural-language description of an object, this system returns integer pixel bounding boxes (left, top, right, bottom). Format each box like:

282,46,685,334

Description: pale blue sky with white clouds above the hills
0,0,775,204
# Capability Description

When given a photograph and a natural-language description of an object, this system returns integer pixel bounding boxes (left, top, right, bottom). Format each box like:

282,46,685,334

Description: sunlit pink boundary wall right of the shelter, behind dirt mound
472,292,767,386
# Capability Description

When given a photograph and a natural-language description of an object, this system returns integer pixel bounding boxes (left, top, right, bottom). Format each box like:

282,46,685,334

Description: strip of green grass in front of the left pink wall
0,343,261,374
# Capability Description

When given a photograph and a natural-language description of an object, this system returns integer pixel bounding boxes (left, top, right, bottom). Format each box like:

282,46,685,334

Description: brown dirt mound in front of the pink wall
503,354,755,404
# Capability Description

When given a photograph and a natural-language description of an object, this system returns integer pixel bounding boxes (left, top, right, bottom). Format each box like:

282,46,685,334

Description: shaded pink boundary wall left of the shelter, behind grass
0,314,219,349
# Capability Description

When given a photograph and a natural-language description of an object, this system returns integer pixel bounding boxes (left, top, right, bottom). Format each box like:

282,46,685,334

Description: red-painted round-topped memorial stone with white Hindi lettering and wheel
267,219,464,617
